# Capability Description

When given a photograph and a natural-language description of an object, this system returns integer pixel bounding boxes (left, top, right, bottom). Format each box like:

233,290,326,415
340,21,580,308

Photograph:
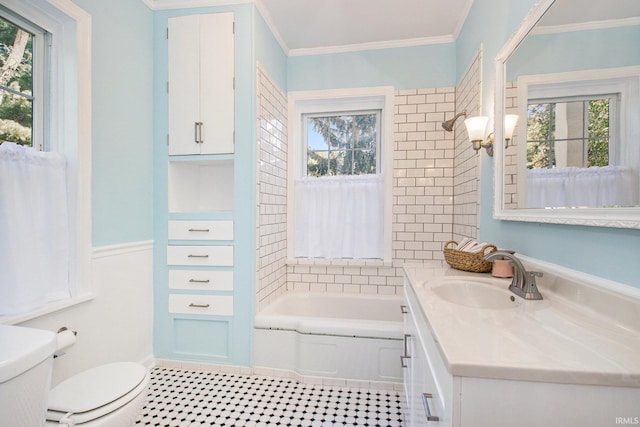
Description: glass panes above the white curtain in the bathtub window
304,110,380,176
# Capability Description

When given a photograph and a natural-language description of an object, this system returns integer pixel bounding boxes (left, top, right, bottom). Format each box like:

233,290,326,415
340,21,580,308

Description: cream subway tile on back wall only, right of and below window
287,87,456,295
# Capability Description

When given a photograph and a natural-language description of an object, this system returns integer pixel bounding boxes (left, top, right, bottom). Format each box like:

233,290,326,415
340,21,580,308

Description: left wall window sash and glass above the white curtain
0,8,48,150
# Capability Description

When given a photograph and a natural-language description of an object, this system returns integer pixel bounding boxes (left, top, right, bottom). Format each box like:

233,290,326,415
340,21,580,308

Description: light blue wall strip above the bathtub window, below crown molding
287,43,456,91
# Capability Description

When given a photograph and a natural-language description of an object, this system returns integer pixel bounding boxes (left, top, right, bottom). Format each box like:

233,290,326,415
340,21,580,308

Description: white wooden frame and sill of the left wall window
0,0,94,324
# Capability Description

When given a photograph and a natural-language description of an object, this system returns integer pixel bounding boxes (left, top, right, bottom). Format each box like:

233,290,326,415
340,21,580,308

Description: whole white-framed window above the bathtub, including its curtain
288,87,395,261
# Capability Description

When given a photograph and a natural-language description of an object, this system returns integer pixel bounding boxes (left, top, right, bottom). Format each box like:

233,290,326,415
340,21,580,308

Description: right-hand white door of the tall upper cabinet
200,13,235,154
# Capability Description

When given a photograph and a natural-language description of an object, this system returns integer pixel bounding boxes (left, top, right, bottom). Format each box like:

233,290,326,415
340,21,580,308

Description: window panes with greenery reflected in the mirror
527,95,618,169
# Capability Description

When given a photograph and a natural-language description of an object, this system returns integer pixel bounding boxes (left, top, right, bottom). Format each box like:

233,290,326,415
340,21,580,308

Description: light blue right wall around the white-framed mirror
457,0,640,287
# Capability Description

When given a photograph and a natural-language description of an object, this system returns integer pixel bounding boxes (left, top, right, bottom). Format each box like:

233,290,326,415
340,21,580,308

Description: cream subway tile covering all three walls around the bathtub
257,64,481,304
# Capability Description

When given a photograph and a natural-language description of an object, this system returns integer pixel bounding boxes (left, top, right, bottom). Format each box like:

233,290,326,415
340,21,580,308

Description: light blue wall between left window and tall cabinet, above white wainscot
74,0,153,246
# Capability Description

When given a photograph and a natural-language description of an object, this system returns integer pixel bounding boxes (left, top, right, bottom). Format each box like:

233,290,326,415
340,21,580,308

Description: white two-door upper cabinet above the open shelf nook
167,13,235,155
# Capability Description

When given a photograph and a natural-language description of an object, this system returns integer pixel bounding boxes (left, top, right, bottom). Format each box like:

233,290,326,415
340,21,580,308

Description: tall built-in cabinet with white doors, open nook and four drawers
154,12,250,364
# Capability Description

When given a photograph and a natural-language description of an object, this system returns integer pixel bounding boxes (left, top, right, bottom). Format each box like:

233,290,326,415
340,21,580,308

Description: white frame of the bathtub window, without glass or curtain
287,86,395,263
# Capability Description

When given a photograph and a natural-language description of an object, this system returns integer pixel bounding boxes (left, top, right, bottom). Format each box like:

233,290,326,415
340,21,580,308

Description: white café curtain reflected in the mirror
527,166,638,208
